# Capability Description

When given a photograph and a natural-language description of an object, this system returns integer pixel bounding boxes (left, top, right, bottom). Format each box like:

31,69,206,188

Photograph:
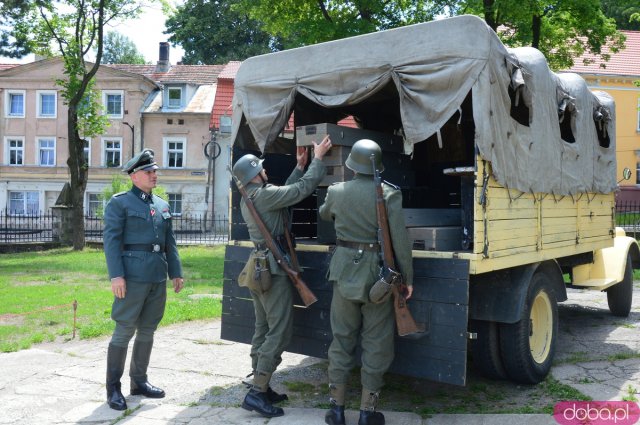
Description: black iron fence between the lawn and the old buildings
0,210,229,245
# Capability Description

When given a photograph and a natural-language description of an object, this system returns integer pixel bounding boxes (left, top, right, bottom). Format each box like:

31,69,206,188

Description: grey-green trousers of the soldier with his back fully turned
329,285,395,391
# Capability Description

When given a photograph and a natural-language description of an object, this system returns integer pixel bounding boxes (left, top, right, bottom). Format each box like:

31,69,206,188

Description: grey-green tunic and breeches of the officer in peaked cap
104,186,182,347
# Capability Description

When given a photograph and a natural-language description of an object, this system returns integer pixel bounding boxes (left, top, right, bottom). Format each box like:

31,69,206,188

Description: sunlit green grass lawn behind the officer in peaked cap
0,245,224,352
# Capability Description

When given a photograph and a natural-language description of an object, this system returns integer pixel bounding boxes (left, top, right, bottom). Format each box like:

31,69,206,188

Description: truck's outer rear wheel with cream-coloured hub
500,270,558,384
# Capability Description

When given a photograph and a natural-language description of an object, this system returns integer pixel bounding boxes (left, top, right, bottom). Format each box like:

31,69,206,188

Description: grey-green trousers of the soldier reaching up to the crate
251,275,293,373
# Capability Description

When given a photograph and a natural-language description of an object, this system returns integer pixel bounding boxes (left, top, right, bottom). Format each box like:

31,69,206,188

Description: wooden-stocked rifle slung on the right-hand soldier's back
371,155,425,336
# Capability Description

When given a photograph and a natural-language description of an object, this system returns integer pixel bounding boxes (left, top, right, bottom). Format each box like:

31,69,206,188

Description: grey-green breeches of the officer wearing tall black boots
111,282,167,347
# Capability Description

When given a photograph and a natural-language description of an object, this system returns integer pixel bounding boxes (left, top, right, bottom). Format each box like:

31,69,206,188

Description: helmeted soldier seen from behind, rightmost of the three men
319,139,413,425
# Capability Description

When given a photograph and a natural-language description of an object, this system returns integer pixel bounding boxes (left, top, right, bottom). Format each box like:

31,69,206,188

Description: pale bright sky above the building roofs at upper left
0,0,184,64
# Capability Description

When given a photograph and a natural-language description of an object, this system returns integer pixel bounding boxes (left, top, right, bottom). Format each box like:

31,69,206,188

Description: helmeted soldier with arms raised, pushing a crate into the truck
233,136,331,417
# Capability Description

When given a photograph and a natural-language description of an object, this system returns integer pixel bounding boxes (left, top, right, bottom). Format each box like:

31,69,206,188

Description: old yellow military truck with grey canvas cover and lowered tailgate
221,16,640,385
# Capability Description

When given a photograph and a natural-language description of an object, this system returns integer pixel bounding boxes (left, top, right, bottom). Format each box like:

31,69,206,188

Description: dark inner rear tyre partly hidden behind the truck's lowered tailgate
469,320,507,380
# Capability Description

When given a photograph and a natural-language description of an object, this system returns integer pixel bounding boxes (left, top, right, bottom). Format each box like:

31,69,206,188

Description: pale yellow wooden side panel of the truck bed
471,159,615,273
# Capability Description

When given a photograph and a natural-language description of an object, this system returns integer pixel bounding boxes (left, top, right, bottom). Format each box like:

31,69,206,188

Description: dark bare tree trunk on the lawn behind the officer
67,104,89,251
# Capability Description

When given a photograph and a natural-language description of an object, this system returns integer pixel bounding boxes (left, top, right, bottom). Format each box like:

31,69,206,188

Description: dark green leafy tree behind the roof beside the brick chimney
165,0,281,64
